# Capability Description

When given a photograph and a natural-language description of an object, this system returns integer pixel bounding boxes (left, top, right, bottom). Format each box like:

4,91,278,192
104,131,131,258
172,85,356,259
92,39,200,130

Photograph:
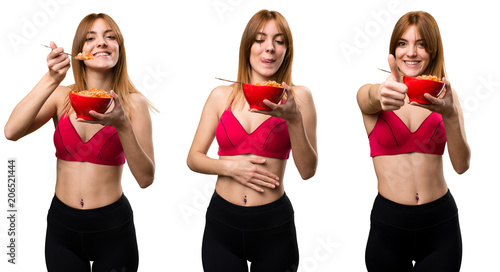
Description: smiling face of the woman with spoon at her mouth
82,18,120,69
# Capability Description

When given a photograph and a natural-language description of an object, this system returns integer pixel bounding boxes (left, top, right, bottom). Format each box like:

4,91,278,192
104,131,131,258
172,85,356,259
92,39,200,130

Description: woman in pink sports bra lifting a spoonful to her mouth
5,13,155,272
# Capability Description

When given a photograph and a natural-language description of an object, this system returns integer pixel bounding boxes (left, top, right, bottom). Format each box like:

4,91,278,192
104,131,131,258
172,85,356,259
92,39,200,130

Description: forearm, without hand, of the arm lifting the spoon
4,73,59,141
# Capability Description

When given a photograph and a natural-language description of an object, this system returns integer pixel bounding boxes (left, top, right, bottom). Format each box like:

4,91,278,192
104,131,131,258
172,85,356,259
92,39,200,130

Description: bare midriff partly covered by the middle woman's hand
215,154,286,206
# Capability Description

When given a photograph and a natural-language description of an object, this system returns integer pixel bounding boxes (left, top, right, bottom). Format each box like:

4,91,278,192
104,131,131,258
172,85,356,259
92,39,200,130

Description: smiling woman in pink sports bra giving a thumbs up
357,11,470,272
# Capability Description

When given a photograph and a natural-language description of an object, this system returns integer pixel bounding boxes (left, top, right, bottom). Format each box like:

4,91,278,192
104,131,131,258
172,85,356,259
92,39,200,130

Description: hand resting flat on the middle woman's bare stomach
228,157,280,193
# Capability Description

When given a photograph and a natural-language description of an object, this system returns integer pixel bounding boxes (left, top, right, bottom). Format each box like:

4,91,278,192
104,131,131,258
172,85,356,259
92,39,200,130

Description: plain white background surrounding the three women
0,0,500,272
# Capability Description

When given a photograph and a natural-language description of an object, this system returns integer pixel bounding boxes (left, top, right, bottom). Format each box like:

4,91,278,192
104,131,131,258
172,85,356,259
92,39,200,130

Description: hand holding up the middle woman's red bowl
250,82,302,122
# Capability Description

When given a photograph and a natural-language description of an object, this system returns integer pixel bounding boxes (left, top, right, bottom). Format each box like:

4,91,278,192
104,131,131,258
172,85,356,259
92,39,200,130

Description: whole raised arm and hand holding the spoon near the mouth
4,42,70,141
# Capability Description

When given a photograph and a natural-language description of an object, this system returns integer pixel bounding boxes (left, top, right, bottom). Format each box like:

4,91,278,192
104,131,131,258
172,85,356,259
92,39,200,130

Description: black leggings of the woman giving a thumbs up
365,191,462,272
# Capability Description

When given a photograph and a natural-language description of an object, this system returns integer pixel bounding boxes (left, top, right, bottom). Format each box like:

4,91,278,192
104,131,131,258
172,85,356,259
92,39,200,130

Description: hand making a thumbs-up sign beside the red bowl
379,54,408,111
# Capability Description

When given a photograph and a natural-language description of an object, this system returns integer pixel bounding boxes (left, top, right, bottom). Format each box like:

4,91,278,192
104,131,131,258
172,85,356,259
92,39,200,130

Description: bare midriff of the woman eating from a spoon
56,159,123,209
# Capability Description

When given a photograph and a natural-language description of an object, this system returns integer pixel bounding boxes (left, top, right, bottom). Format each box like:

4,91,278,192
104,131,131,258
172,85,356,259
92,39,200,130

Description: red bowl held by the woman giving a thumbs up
403,76,444,104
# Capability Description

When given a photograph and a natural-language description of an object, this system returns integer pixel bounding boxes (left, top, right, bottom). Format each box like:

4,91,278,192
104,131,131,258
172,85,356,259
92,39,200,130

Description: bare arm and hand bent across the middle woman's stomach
187,86,279,192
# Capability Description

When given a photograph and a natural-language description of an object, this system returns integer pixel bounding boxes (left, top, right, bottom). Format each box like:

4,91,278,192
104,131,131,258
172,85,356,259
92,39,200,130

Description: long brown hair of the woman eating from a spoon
63,13,158,113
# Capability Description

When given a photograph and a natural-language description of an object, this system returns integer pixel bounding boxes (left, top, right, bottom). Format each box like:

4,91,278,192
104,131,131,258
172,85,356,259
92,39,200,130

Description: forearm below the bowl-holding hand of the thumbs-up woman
443,111,471,174
